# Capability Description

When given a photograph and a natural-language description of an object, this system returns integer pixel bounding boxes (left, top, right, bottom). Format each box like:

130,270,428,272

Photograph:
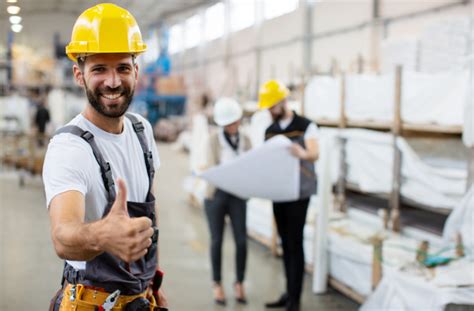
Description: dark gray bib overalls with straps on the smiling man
50,114,158,310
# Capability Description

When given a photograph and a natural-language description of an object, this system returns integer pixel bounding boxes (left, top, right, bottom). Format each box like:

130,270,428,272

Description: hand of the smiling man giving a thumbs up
98,179,153,263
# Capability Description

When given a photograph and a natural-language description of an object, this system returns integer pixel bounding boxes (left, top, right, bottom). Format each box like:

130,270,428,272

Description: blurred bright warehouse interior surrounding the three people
0,0,474,311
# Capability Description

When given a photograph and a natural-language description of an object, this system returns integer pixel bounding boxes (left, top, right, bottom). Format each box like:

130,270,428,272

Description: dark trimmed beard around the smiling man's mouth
84,81,135,118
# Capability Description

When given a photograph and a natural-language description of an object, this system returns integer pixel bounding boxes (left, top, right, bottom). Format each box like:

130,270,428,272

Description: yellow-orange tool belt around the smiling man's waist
59,284,161,311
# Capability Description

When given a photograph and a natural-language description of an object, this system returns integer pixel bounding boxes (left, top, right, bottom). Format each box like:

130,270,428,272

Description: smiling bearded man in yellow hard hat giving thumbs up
43,4,167,311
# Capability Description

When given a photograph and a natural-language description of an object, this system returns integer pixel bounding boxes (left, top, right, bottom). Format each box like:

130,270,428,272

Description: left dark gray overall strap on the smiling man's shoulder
54,125,115,202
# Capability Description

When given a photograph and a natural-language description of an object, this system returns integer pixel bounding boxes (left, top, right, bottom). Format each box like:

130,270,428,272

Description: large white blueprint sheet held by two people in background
200,135,300,202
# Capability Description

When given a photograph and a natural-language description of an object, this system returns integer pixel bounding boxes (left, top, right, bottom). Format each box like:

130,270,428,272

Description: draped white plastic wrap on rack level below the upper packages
334,129,467,208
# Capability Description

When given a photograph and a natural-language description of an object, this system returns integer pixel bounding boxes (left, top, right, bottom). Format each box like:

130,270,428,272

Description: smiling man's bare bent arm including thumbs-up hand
49,179,153,262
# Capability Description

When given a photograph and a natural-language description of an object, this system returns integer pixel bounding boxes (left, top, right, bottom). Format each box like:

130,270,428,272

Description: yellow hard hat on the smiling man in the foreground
66,3,146,62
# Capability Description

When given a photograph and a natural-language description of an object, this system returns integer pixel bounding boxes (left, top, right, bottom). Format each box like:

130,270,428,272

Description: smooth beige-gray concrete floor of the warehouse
0,144,358,311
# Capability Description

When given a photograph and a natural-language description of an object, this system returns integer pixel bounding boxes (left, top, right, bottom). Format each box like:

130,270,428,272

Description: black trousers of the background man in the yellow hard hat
273,198,309,303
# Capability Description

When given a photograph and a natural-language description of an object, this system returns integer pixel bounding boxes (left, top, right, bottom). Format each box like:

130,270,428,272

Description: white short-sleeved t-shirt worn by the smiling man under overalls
43,114,160,269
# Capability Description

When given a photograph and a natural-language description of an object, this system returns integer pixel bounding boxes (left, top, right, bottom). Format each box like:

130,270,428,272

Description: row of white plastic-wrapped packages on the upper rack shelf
305,70,472,126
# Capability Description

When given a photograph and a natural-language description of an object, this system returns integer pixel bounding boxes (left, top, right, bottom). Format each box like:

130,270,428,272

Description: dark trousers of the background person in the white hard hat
205,189,247,283
